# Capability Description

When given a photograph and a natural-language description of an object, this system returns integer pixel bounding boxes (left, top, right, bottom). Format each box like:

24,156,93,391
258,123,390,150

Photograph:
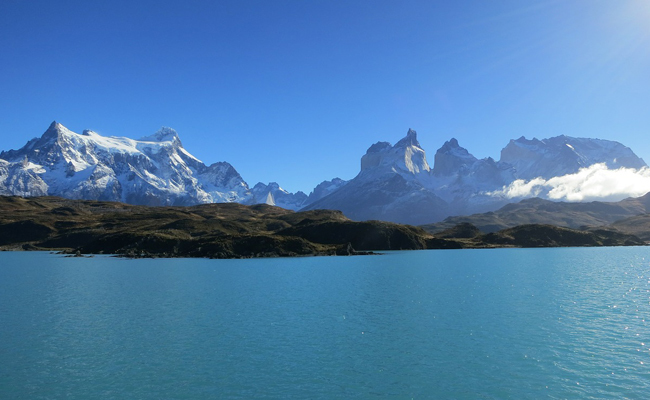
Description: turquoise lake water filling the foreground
0,247,650,399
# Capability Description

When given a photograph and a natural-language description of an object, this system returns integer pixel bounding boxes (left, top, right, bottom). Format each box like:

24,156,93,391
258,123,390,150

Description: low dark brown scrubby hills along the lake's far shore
0,196,644,258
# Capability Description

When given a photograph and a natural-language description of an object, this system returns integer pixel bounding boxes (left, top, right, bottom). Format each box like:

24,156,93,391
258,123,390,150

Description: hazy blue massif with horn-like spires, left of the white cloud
305,129,513,224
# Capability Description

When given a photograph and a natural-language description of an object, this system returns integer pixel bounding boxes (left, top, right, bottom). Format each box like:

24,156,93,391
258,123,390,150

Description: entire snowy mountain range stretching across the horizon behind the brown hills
0,122,646,224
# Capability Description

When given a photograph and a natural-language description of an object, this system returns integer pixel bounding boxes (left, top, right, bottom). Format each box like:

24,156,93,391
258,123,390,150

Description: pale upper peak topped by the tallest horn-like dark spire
361,129,431,174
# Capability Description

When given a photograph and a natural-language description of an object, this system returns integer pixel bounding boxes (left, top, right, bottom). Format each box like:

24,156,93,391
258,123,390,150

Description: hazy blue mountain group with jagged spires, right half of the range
305,129,646,224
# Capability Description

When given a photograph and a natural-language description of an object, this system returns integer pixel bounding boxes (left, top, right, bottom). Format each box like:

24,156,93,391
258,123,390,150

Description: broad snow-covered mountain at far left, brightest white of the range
0,122,252,205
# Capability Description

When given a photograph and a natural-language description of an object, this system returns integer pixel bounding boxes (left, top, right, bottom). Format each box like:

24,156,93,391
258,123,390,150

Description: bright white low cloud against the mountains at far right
487,163,650,201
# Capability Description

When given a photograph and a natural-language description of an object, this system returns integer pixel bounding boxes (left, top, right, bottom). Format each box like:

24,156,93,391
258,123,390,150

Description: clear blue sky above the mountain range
0,0,650,192
